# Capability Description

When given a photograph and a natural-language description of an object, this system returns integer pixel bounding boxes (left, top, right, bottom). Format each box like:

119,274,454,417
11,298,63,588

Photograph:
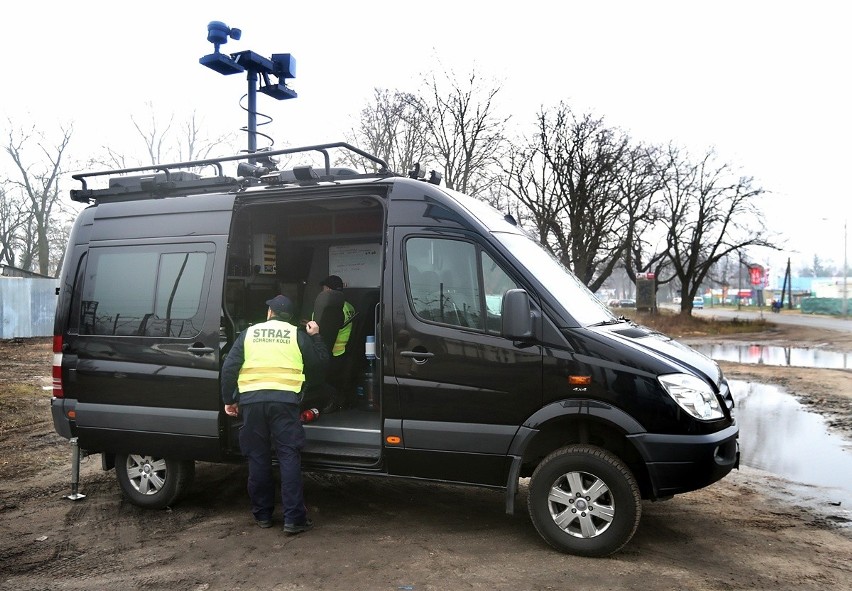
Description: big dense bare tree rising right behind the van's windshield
501,104,665,290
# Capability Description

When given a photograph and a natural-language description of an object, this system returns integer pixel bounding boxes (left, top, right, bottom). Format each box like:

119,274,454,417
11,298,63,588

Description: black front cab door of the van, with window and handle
384,226,542,485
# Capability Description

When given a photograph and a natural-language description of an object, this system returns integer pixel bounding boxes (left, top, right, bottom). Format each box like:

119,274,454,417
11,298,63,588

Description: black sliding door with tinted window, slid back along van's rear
57,195,234,460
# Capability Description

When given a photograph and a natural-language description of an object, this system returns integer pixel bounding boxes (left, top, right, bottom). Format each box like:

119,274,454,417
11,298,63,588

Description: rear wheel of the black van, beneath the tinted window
115,454,195,509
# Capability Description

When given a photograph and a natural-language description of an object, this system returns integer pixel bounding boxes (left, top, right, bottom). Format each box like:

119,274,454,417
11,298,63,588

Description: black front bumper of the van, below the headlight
629,423,740,498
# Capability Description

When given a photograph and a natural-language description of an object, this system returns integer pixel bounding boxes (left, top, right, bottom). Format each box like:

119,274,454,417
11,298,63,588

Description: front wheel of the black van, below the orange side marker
527,445,642,557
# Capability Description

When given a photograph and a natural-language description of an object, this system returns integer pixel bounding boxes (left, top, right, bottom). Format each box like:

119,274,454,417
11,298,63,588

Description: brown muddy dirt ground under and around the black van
0,327,852,591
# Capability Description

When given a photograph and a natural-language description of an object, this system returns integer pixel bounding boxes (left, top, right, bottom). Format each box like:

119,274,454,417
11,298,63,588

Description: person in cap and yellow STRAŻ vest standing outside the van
222,295,328,534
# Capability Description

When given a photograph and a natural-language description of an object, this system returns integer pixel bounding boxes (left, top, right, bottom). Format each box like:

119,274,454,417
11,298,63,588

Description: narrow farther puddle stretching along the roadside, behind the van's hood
690,344,852,369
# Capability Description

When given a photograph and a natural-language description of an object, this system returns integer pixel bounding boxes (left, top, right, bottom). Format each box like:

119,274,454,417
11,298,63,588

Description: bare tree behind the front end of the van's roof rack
345,88,429,174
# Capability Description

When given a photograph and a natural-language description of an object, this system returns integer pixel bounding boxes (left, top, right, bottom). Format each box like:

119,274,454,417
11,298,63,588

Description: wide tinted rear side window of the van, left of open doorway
80,246,210,337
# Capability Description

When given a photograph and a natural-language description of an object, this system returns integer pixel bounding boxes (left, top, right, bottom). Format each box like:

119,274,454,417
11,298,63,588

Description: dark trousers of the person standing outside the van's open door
240,402,307,524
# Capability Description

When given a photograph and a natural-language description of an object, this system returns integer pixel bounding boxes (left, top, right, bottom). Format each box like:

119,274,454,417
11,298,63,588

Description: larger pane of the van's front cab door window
405,238,484,330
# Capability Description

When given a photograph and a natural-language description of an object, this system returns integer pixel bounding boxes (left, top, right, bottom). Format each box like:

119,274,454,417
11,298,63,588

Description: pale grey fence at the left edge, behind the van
0,277,59,339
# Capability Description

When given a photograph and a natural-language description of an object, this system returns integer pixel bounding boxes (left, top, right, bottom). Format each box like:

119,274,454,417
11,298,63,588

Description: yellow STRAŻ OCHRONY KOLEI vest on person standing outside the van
237,320,305,393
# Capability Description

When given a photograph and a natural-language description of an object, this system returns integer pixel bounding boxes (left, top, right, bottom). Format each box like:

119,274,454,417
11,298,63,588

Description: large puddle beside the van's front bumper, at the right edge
730,380,852,526
